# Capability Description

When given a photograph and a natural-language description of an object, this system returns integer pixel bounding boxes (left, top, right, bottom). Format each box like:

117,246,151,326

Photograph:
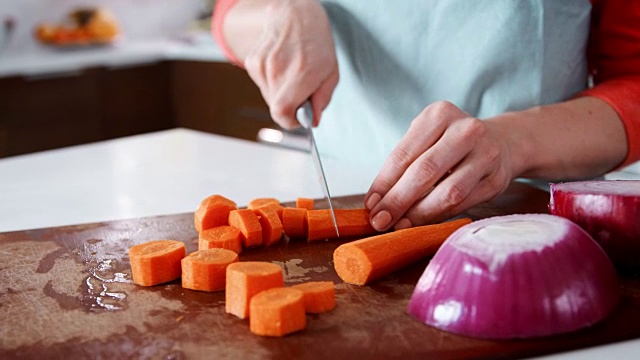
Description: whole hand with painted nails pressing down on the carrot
365,102,514,231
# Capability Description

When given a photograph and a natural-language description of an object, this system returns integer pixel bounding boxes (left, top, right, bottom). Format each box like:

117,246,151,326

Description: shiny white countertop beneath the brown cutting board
0,129,640,360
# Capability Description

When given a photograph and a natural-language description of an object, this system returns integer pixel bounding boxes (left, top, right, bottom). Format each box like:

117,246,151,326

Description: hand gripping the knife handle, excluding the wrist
244,0,339,129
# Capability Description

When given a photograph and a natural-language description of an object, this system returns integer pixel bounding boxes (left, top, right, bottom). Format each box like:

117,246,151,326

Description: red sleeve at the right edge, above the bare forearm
581,0,640,166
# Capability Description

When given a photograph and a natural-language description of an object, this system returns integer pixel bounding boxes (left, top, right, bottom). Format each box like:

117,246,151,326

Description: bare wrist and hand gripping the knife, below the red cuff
212,0,339,128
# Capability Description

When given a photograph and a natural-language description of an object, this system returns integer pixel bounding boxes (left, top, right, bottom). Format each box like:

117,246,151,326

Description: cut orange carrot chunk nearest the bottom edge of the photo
249,287,307,336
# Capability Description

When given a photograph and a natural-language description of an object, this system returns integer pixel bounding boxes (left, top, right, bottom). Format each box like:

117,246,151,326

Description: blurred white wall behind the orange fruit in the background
0,0,206,51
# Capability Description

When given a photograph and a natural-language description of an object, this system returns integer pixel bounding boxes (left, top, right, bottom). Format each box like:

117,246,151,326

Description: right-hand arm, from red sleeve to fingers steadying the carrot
365,0,640,230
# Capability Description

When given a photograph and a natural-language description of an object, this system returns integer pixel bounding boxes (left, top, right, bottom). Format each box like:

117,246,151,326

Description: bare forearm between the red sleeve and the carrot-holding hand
488,96,628,180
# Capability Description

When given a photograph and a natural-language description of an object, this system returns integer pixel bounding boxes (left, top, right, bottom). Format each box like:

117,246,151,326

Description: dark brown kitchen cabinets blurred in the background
0,61,275,157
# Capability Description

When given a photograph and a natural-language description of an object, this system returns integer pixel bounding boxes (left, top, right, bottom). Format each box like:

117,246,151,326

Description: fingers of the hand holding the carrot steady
365,103,479,231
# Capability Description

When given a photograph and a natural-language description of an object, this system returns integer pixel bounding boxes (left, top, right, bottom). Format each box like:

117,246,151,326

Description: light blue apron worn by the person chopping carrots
316,0,591,172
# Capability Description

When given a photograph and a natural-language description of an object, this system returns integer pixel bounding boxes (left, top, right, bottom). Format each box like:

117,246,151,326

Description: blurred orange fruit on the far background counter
35,8,120,46
